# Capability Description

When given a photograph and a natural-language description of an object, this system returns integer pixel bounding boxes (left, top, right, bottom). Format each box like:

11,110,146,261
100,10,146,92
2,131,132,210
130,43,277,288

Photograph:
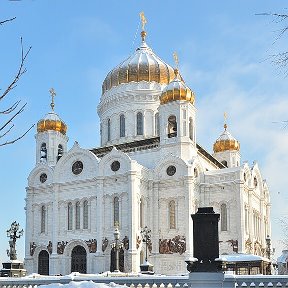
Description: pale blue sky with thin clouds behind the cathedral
0,0,288,262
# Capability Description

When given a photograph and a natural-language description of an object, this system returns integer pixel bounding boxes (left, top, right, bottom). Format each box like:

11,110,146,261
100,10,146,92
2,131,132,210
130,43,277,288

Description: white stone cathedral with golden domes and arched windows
25,19,270,275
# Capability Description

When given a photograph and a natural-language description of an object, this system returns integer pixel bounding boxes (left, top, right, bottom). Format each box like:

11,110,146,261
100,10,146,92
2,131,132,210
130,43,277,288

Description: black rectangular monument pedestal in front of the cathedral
186,207,222,272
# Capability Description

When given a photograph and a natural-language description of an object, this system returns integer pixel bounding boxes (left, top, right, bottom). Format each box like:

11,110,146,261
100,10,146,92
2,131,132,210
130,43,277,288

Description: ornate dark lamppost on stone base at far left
0,221,26,277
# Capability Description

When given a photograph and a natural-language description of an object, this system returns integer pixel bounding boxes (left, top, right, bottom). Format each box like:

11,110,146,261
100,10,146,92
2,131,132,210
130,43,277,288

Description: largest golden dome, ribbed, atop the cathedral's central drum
102,31,175,94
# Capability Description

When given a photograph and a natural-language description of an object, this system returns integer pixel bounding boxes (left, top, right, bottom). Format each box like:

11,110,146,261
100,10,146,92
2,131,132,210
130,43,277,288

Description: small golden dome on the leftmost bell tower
37,111,67,135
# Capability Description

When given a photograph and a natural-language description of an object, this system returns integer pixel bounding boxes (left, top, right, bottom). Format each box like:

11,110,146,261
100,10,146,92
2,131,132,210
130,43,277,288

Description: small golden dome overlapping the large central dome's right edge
160,69,195,105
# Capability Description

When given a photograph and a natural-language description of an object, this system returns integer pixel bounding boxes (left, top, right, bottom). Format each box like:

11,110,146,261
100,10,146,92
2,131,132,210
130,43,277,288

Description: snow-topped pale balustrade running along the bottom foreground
0,273,288,288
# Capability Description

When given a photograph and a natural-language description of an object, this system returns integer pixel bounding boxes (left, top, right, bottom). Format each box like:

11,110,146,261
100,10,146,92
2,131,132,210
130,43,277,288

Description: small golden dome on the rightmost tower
213,124,240,153
